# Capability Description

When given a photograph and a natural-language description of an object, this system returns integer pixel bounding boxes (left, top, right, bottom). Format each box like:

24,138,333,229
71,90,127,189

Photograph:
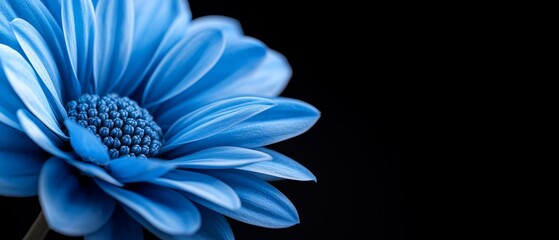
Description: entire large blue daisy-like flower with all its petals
0,0,320,239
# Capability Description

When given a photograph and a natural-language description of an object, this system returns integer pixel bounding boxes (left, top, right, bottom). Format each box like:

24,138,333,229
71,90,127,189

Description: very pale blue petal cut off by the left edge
0,45,64,137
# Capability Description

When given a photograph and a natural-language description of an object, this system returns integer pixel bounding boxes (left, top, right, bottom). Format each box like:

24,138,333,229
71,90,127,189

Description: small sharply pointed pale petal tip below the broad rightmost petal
237,148,316,182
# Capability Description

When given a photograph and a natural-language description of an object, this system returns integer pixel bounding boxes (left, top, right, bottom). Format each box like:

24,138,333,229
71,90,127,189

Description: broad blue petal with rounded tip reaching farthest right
172,98,320,156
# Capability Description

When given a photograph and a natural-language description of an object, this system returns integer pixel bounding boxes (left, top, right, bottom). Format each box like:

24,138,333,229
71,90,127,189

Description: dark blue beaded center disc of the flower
66,94,162,159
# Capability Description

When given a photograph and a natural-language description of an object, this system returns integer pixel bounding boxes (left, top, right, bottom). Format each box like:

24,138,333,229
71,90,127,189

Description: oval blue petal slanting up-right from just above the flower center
142,30,225,107
